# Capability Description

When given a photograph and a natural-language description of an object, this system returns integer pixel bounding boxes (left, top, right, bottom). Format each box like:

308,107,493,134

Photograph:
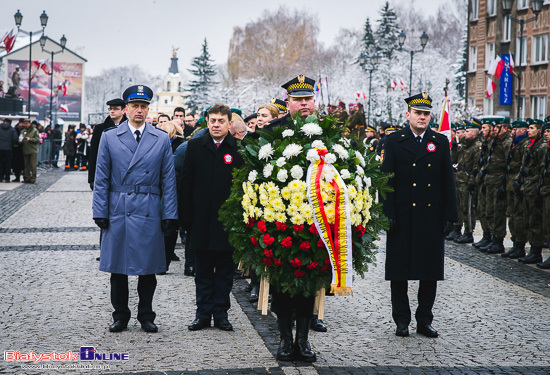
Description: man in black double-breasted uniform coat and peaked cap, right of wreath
382,93,458,337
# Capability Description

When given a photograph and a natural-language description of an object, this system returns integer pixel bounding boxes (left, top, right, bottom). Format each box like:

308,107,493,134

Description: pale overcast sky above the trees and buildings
0,0,447,75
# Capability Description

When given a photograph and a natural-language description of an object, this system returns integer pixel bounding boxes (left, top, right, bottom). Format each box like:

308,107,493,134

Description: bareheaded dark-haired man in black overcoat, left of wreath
178,104,244,331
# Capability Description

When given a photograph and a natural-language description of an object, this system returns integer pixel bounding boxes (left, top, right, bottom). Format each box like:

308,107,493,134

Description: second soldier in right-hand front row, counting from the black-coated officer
472,118,496,248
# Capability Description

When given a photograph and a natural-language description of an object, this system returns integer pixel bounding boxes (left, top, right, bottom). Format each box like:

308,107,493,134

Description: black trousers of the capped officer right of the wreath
390,280,437,325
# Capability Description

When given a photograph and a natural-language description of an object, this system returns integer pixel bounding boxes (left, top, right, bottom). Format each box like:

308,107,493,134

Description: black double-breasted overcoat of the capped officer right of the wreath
382,127,458,280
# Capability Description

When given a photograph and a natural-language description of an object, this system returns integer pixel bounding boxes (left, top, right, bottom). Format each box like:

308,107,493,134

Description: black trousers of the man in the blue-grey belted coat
111,273,157,322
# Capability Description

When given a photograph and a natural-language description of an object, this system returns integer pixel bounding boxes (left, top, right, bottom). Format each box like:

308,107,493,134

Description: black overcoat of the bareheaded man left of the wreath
178,133,244,252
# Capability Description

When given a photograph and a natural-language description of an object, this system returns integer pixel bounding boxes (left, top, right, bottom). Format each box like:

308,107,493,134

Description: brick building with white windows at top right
466,0,550,119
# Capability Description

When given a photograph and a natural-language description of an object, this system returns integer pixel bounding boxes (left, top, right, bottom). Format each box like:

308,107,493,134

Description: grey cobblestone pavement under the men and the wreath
0,171,550,375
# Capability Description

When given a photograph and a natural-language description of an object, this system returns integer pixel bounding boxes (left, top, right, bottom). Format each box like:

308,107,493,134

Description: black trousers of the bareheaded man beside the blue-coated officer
195,250,235,320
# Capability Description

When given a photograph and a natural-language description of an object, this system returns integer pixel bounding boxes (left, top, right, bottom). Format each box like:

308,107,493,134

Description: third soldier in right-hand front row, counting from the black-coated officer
500,120,529,259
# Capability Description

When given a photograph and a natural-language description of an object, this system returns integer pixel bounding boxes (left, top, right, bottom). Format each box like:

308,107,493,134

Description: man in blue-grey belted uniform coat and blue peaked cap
93,85,177,332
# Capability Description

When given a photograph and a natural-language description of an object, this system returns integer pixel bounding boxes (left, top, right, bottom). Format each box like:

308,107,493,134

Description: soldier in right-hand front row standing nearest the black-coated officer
454,122,481,243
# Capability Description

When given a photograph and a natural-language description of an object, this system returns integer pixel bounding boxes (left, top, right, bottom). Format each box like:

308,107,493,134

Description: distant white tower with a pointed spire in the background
149,49,186,119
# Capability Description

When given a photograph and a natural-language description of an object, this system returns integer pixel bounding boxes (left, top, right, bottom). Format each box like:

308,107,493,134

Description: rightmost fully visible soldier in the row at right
514,119,547,264
